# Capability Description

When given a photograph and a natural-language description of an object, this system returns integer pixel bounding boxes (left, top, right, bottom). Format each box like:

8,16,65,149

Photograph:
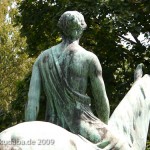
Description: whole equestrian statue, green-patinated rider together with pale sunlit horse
0,11,150,150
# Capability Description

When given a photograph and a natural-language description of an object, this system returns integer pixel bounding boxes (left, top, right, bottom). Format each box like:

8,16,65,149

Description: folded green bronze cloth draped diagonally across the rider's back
38,46,102,132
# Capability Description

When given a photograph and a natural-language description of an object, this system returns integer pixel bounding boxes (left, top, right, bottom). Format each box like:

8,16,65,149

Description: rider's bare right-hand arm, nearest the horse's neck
90,55,110,124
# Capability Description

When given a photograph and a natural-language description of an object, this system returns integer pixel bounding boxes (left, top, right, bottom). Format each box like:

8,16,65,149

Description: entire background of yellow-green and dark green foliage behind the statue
0,0,150,149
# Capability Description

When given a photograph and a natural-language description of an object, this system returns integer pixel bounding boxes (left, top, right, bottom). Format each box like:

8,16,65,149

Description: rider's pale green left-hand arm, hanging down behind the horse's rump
25,61,41,121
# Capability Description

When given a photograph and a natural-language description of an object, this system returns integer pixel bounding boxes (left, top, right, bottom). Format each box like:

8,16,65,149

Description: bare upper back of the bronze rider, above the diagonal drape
39,44,93,94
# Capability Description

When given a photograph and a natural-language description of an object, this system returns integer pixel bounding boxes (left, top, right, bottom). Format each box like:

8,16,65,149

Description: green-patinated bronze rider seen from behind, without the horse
25,11,110,143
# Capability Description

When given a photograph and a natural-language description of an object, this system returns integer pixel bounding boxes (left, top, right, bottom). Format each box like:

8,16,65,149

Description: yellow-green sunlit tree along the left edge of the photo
0,0,31,130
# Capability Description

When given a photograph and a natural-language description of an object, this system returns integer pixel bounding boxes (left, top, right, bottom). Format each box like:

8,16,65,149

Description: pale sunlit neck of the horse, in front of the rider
109,75,150,150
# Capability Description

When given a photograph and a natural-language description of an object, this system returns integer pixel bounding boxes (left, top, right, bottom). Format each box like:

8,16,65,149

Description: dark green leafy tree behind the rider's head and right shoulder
18,0,150,110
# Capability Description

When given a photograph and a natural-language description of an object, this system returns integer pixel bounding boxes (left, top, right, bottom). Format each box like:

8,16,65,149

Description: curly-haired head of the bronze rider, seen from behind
58,11,87,40
